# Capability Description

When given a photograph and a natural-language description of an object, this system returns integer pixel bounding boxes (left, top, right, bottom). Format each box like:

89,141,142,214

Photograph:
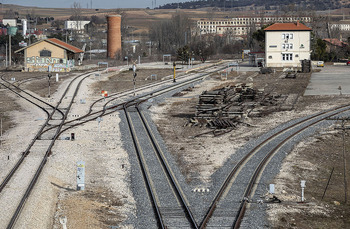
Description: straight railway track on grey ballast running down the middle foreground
124,104,198,229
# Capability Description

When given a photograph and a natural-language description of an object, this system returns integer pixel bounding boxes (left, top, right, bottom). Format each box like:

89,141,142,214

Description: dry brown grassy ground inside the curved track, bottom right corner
270,130,350,229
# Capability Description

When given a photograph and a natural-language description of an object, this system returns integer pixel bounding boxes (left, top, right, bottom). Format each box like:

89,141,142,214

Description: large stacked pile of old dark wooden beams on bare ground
186,84,280,130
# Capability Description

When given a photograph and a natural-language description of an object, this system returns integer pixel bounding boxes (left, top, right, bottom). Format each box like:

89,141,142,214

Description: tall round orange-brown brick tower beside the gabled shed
107,15,122,58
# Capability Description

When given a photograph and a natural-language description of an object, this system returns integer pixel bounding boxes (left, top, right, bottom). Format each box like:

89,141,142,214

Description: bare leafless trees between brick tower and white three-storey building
149,13,246,63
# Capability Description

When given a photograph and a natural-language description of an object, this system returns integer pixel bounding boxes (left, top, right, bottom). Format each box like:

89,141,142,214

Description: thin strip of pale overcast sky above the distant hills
0,0,190,9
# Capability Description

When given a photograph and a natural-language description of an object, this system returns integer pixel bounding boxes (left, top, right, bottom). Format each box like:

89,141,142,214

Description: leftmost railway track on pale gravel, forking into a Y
0,70,93,229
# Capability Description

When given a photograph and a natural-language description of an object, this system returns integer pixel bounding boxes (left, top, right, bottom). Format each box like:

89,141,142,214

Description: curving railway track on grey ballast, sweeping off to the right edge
200,106,350,228
